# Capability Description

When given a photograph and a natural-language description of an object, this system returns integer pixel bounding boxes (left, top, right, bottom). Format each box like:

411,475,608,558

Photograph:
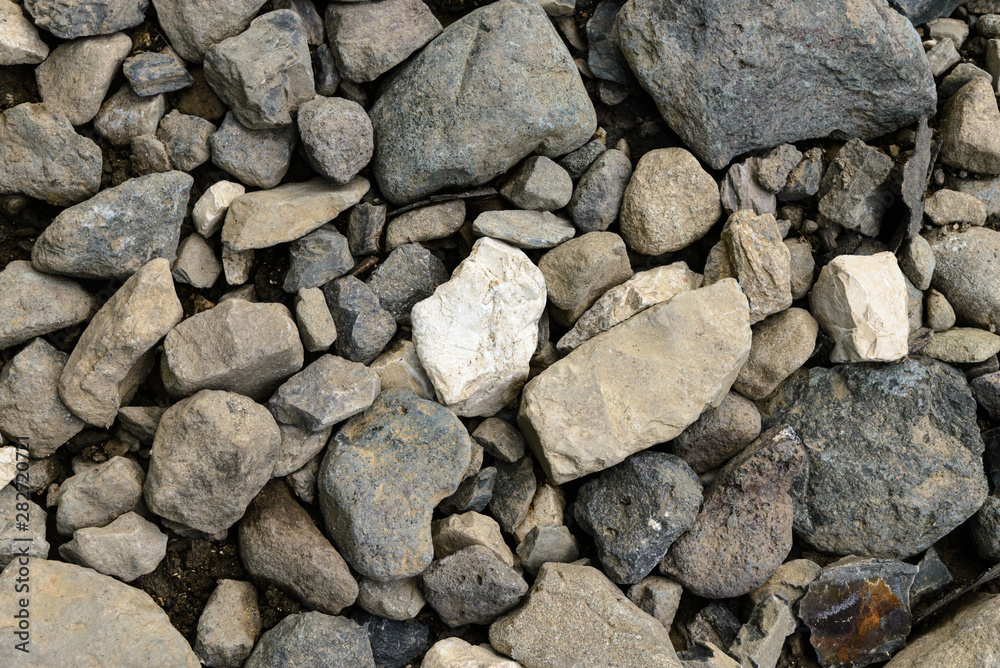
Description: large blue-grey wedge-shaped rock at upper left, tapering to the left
31,172,194,279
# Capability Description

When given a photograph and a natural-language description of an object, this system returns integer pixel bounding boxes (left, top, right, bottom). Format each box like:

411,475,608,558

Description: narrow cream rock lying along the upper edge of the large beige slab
556,262,702,353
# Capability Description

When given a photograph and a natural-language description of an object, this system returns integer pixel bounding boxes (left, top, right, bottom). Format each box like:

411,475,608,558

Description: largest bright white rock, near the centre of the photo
411,238,545,416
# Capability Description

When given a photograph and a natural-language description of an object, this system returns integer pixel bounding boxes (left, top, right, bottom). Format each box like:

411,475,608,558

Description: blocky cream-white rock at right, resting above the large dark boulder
809,252,910,362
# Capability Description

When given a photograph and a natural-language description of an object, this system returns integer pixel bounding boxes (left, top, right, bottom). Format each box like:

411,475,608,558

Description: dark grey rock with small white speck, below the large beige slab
573,452,701,584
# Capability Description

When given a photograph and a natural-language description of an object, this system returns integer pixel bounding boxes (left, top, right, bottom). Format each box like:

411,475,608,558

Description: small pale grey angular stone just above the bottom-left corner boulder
59,512,167,582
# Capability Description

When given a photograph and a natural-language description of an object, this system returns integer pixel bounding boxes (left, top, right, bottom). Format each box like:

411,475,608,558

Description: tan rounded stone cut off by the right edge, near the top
938,78,1000,174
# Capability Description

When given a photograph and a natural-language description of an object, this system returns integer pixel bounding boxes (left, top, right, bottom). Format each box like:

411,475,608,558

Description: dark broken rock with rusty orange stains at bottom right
799,557,917,666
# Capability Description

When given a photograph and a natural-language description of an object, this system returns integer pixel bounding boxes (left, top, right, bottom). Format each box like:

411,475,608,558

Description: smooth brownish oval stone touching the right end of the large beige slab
732,308,819,402
